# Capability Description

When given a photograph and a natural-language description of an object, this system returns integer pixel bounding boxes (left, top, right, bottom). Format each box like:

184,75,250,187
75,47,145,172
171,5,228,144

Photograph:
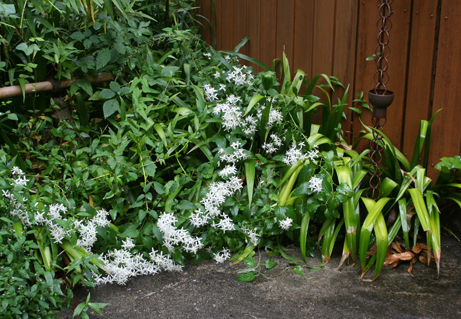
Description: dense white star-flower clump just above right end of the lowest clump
157,213,203,254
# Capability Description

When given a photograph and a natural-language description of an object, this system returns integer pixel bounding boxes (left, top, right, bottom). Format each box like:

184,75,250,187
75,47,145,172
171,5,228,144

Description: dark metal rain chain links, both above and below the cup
366,0,393,200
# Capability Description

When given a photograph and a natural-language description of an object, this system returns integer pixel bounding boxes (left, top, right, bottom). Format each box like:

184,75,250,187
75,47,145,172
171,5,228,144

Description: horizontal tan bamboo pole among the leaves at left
0,72,115,100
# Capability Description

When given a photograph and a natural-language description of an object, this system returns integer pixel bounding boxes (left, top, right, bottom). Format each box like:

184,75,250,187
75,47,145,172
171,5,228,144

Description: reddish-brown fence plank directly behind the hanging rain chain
354,0,411,149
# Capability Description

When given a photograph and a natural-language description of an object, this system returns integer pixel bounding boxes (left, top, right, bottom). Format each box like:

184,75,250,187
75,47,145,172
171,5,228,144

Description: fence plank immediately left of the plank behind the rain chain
332,0,359,143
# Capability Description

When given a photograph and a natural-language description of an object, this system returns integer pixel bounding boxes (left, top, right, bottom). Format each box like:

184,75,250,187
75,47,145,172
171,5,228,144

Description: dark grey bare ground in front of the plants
59,237,461,319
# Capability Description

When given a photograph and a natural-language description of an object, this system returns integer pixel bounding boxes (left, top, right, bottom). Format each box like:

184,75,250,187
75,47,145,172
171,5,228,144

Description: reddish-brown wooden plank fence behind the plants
198,0,461,177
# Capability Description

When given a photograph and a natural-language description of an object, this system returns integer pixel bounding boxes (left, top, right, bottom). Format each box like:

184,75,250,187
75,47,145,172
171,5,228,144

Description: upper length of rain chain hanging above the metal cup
374,0,394,94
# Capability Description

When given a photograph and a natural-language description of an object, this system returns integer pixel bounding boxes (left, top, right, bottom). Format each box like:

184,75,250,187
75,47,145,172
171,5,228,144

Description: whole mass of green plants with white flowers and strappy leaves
0,0,460,317
